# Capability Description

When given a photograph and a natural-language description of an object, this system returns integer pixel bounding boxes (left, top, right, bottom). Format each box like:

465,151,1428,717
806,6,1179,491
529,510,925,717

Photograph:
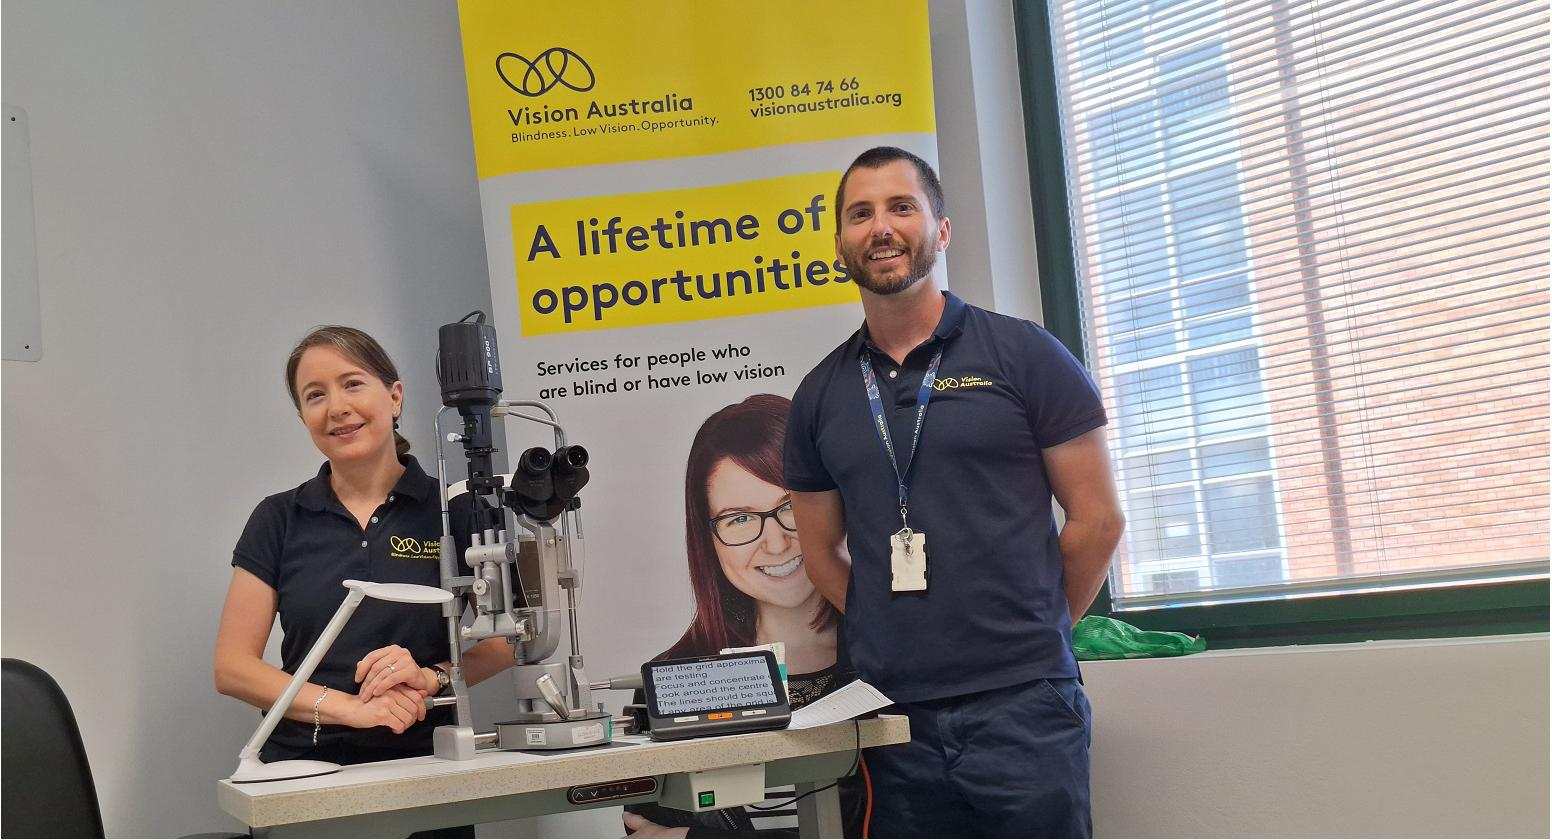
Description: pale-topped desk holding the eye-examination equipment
225,714,911,837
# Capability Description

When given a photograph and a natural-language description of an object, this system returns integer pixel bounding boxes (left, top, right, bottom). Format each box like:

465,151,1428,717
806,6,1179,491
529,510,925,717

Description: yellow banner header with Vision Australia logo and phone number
458,0,934,180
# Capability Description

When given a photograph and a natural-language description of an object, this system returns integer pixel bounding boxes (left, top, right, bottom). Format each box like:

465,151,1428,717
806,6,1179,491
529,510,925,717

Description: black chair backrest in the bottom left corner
0,658,102,837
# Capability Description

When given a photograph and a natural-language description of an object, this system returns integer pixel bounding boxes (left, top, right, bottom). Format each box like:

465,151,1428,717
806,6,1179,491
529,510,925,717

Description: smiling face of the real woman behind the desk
296,346,404,463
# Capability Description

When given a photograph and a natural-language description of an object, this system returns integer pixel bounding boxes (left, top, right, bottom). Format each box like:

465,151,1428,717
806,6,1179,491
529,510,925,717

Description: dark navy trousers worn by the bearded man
868,679,1094,837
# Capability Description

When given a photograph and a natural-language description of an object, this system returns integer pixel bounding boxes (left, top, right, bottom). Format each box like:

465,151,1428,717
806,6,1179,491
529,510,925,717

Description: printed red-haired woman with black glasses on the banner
625,394,863,837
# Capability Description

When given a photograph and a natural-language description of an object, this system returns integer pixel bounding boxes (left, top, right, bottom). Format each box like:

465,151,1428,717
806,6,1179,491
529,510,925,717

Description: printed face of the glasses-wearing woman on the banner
706,458,813,607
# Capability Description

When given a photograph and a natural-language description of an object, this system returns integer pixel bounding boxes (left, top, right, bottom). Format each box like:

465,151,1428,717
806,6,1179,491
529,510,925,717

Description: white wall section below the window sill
1083,633,1549,837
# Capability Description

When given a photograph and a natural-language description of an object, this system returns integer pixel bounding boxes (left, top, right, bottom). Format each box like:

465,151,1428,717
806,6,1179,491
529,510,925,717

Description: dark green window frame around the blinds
1013,0,1552,647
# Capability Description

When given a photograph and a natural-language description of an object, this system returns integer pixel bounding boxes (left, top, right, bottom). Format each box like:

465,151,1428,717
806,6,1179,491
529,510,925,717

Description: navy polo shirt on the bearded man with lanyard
785,292,1105,702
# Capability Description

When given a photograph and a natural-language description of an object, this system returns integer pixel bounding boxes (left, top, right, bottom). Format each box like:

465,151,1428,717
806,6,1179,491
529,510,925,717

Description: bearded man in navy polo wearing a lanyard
784,148,1122,837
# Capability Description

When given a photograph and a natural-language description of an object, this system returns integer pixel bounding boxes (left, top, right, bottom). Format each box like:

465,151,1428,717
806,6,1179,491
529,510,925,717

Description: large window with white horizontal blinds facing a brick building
1018,0,1549,630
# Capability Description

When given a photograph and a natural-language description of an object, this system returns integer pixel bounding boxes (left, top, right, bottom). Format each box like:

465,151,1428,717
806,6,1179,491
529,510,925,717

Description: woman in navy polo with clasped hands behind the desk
214,326,512,785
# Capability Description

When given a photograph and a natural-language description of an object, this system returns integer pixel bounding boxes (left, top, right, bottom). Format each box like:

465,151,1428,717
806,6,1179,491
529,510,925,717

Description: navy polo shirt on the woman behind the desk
231,456,453,761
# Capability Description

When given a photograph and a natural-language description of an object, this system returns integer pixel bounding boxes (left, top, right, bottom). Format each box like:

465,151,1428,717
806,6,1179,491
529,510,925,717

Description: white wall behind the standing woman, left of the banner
3,0,490,837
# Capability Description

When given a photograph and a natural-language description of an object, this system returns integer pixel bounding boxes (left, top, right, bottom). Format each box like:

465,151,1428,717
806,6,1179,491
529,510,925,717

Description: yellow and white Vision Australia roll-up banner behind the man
459,0,937,708
